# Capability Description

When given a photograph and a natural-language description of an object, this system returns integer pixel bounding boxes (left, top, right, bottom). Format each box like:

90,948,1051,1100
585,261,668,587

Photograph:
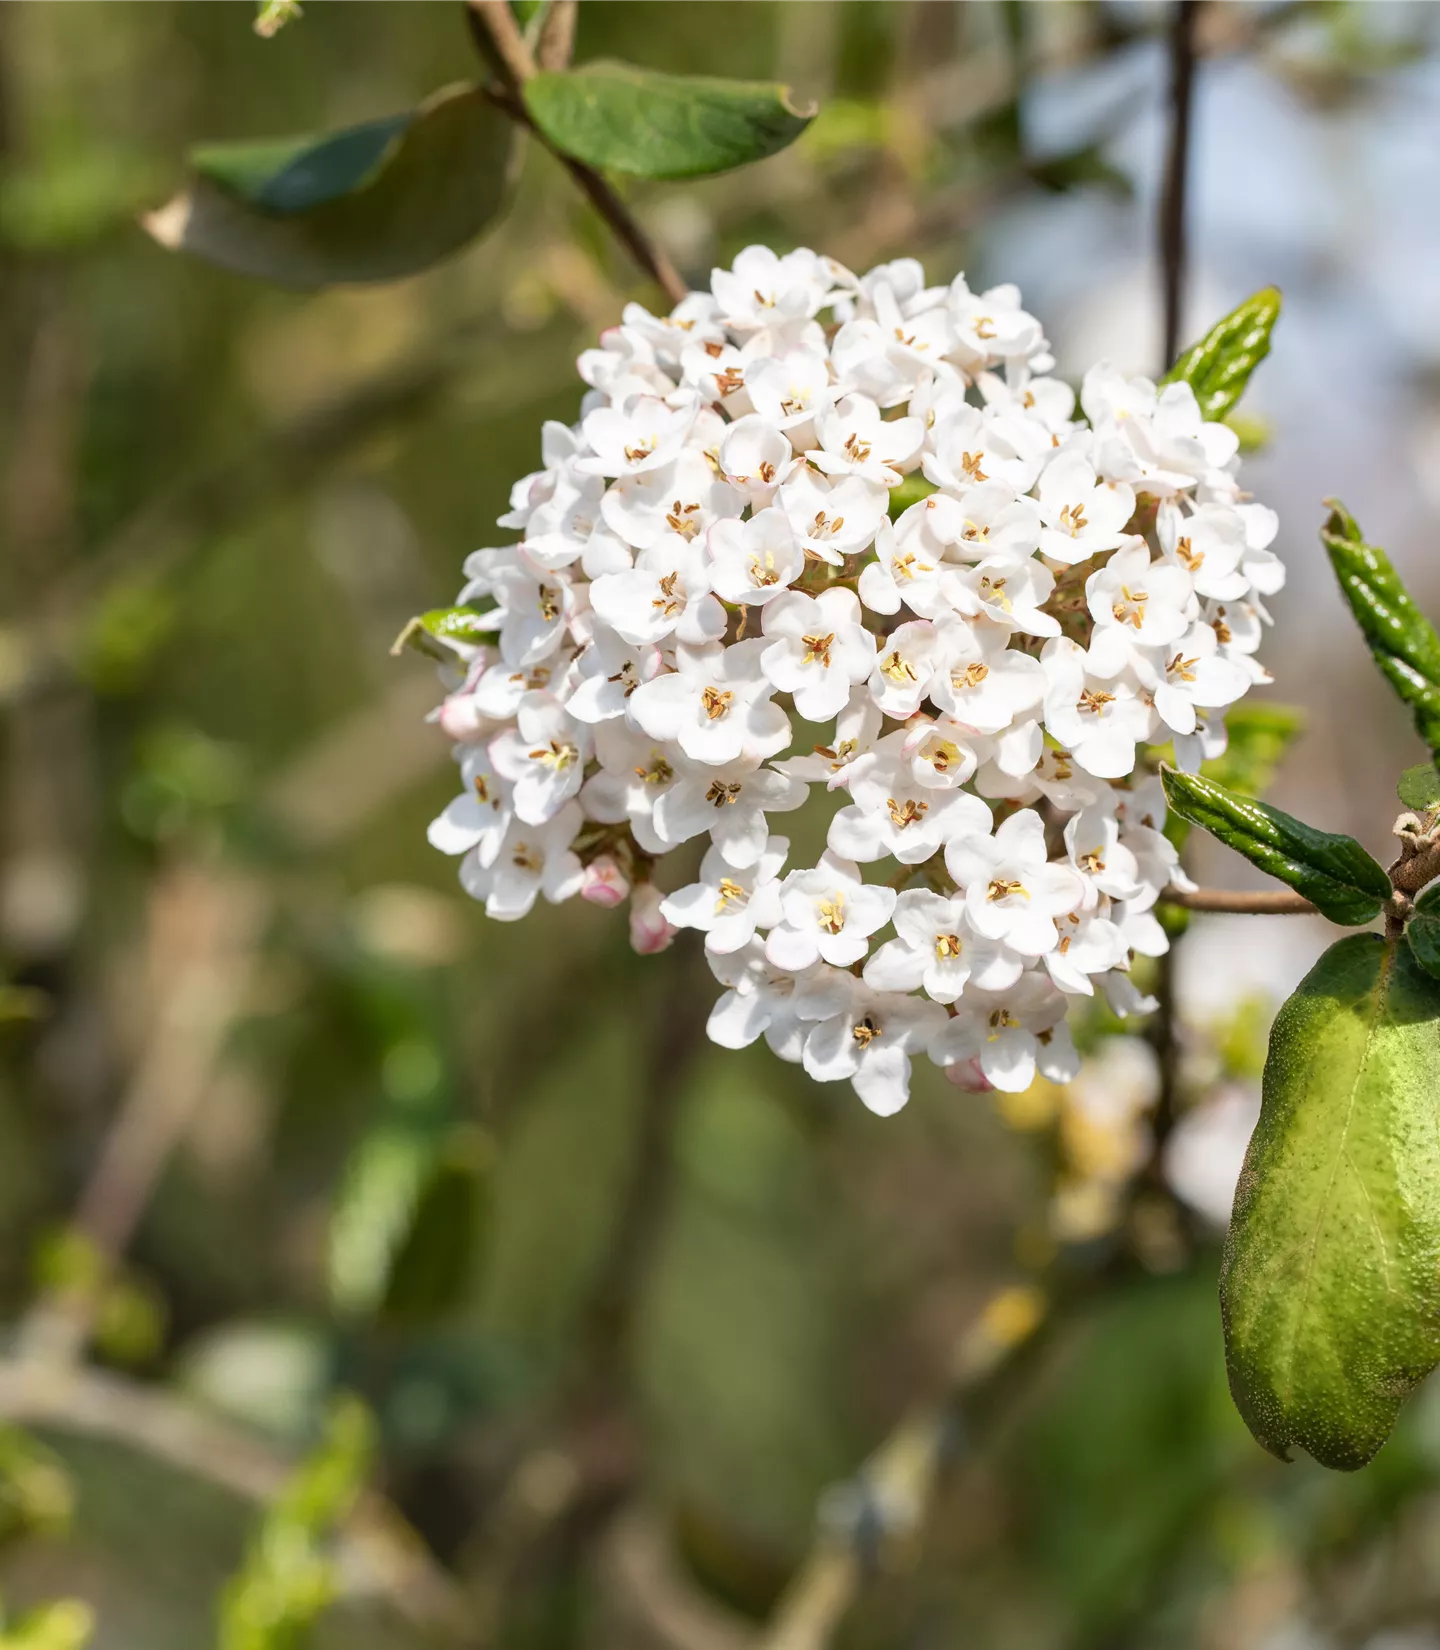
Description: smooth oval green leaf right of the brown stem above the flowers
525,63,815,178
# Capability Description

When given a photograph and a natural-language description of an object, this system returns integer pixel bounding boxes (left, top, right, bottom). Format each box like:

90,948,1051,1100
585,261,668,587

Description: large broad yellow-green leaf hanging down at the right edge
1221,934,1440,1470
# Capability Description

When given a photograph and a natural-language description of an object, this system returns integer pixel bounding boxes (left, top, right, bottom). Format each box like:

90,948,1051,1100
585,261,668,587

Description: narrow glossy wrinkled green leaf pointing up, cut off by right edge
1320,498,1440,754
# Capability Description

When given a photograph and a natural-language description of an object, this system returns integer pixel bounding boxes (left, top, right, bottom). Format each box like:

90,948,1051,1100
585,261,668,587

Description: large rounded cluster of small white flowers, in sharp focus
431,248,1283,1112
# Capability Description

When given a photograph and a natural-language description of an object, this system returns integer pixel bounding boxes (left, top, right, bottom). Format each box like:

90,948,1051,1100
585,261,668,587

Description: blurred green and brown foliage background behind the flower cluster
0,0,1440,1650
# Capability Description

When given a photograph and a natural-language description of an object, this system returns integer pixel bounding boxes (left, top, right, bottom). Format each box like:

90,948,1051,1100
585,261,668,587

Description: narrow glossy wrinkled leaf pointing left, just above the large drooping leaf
1161,767,1391,927
